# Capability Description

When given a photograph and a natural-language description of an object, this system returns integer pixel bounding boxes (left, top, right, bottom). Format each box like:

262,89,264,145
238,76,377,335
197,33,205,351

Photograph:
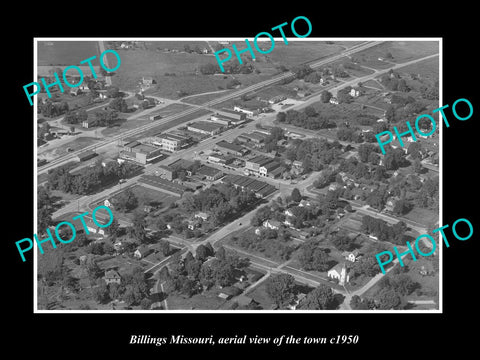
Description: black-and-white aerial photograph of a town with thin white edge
32,38,442,313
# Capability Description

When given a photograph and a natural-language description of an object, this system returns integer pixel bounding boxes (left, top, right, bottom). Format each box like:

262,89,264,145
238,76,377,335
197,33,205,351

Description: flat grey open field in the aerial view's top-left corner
37,39,100,67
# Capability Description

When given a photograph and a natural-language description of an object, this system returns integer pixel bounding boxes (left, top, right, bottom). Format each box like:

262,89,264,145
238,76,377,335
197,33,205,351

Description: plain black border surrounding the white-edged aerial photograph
3,3,480,356
